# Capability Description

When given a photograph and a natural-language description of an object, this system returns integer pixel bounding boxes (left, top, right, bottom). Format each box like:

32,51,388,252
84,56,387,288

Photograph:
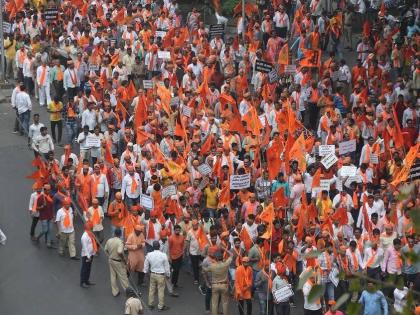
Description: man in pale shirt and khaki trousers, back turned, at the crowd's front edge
144,241,171,311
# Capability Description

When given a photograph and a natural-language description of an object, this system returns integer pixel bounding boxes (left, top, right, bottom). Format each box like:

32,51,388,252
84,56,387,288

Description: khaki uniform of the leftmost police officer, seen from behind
105,237,128,296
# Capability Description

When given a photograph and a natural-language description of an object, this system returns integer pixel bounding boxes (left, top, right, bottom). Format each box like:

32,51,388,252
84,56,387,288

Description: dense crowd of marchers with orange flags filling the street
4,0,420,315
